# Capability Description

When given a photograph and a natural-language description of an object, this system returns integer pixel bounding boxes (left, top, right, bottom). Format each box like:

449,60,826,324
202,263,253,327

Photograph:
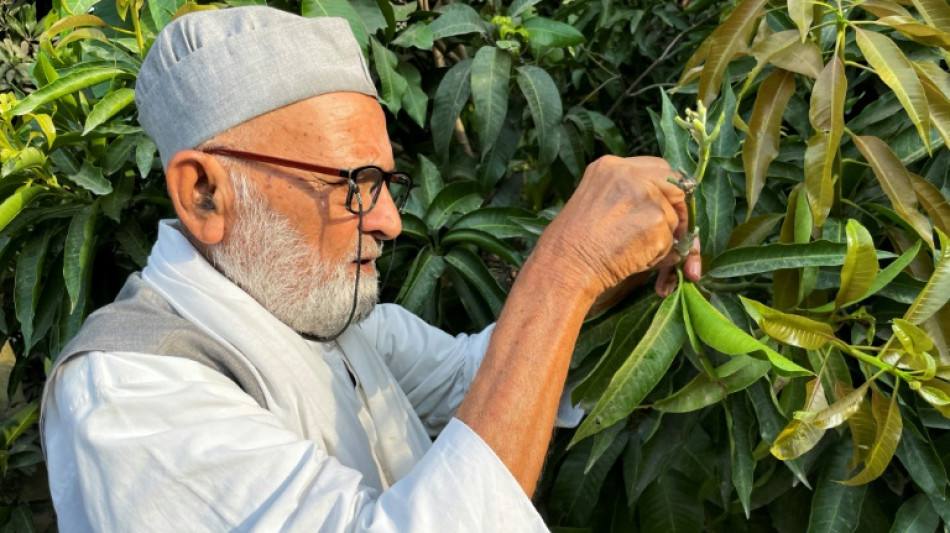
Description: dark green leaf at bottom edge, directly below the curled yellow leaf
808,440,867,533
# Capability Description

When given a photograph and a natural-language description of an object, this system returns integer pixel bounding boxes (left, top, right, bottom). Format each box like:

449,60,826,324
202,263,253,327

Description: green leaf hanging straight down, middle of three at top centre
472,46,511,157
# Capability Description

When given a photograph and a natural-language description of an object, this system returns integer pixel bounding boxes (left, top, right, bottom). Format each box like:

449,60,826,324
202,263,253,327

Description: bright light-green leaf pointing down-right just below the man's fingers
681,283,811,375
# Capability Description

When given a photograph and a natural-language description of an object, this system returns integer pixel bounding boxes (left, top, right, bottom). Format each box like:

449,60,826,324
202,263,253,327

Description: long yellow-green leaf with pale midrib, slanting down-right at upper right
855,28,932,150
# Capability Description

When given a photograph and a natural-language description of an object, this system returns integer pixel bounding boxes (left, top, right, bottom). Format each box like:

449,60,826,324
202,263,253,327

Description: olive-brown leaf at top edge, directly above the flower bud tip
700,0,767,107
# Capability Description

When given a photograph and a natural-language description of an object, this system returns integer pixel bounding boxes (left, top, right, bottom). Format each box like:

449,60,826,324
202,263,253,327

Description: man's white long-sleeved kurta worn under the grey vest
43,221,578,533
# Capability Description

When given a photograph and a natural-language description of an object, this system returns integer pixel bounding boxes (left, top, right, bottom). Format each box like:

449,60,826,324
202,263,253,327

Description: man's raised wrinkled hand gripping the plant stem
538,156,700,304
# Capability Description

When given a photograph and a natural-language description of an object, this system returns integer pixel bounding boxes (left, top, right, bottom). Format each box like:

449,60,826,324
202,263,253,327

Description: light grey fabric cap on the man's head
135,6,376,168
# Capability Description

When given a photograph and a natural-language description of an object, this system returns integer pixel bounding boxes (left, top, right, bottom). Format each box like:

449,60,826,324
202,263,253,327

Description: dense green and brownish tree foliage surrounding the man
0,0,950,532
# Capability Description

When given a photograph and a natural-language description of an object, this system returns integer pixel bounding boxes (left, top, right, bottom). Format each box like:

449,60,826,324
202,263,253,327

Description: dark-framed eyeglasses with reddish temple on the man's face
203,148,412,215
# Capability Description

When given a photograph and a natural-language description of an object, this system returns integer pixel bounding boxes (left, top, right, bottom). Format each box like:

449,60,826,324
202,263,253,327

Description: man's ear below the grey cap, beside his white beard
165,150,234,245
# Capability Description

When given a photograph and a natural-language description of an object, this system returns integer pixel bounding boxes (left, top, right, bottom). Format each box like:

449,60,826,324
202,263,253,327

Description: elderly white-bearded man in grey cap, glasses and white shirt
42,7,698,533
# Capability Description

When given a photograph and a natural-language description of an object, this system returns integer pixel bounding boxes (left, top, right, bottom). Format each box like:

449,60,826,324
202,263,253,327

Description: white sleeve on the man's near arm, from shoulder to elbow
44,352,546,533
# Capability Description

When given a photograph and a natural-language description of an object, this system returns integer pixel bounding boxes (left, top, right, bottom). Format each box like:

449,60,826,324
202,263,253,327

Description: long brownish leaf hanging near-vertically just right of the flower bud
742,69,795,213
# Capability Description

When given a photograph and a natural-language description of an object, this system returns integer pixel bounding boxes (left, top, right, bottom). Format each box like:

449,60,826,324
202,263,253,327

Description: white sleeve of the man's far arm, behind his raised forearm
366,304,584,436
